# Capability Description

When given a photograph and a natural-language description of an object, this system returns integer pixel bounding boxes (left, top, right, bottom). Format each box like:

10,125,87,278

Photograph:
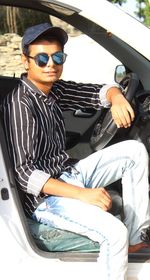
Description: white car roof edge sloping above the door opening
0,0,150,59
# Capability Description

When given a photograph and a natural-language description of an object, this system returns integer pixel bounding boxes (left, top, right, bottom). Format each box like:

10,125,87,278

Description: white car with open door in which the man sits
0,0,150,280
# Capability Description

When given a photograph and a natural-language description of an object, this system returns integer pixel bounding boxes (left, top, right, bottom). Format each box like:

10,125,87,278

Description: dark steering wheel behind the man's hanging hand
90,73,139,151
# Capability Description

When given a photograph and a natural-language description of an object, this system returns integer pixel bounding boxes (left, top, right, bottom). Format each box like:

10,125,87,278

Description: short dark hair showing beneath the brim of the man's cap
23,34,64,56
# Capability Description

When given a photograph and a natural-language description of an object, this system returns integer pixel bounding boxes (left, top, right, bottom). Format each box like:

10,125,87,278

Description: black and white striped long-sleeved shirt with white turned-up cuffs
2,75,110,216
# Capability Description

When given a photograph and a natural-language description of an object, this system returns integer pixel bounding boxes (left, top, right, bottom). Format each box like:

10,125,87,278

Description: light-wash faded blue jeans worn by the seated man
33,140,150,280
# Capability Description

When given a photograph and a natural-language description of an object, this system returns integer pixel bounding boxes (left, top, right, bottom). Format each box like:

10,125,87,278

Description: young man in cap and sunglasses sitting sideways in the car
3,23,150,280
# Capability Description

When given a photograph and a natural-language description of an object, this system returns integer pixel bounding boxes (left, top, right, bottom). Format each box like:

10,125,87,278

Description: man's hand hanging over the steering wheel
107,87,135,128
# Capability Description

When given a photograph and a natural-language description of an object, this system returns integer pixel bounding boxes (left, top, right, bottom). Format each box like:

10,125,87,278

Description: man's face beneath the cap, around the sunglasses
24,40,63,88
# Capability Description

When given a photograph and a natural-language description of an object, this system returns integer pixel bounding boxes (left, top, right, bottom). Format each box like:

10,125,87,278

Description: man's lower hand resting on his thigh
80,188,112,211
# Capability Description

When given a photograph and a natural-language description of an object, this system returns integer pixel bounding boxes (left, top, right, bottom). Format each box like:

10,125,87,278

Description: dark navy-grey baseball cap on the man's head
22,23,68,50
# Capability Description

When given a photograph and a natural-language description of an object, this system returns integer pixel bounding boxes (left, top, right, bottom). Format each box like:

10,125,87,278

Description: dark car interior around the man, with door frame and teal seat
0,1,150,262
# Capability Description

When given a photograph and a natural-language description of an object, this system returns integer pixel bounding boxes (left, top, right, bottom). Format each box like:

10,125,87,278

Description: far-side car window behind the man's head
0,6,120,83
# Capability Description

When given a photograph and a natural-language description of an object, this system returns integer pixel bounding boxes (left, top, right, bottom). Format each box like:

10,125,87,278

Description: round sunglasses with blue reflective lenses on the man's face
27,52,67,67
